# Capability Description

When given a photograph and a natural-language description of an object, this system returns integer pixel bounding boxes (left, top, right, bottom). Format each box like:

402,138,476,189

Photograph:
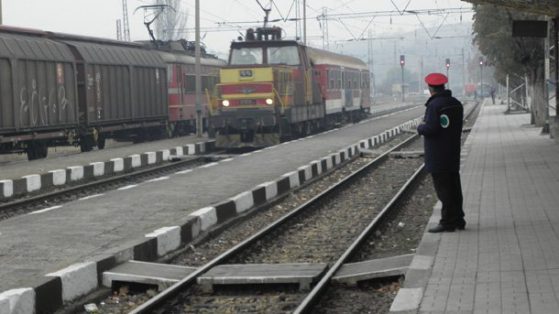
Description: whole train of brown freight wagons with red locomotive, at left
0,26,223,160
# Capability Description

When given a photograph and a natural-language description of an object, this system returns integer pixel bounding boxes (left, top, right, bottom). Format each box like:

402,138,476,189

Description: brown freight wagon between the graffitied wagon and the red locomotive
53,34,168,151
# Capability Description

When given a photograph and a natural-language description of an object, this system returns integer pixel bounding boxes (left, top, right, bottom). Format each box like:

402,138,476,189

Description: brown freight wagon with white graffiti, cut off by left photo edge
0,26,78,160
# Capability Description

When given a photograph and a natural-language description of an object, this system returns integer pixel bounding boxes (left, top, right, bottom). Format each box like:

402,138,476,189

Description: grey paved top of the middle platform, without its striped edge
0,107,423,291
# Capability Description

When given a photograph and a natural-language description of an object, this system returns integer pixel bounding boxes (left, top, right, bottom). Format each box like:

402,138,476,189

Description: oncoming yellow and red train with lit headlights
210,27,371,148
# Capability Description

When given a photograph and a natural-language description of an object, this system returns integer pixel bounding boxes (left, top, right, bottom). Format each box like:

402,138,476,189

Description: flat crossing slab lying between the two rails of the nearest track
198,263,328,292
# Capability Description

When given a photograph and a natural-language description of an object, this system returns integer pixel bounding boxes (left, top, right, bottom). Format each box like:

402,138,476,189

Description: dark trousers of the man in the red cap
431,172,464,226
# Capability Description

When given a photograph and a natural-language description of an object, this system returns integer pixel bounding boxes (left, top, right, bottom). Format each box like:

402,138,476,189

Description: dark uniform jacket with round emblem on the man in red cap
417,90,464,173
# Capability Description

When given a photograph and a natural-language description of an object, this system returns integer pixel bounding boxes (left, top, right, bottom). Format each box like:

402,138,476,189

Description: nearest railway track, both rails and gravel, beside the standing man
120,136,422,313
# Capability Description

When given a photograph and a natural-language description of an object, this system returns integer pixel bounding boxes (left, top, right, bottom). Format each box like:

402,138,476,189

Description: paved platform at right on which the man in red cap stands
391,101,559,314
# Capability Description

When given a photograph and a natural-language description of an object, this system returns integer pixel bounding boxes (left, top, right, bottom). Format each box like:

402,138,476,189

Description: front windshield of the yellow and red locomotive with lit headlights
230,46,301,65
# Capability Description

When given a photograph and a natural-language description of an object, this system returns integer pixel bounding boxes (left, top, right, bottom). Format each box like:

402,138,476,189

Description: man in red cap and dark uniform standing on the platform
417,73,466,233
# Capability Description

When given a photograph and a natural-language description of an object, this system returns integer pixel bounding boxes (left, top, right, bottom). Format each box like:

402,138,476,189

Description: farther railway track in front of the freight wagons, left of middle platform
0,152,225,221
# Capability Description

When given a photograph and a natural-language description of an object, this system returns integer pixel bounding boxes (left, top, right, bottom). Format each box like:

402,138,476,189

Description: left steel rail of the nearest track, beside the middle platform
130,134,418,314
